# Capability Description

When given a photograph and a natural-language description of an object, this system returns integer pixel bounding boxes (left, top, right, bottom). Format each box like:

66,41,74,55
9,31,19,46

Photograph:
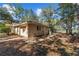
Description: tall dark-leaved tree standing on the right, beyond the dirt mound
59,3,76,34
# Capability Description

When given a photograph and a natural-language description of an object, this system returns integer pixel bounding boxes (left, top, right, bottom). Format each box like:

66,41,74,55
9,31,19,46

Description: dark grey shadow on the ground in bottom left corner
0,47,28,56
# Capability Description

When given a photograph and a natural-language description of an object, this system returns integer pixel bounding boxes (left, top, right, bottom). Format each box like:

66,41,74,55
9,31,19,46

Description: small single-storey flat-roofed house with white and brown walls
11,21,48,38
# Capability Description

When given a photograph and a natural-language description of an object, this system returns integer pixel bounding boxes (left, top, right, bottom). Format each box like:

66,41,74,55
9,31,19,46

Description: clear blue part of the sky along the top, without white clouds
0,3,59,10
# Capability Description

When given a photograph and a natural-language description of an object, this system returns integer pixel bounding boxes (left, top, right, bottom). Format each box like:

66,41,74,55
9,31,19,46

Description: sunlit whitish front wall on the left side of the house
12,25,28,38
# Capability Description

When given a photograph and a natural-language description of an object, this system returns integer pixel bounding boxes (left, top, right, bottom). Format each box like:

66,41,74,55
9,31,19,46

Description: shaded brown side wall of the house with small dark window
28,24,48,37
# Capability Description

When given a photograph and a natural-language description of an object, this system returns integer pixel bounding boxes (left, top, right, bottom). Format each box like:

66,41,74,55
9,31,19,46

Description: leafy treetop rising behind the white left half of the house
14,4,37,22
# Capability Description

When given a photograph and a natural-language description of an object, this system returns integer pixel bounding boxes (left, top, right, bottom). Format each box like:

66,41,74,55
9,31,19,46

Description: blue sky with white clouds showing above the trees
0,3,60,18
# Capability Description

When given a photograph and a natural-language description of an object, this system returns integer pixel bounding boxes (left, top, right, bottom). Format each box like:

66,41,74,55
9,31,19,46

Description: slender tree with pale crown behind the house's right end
42,6,54,34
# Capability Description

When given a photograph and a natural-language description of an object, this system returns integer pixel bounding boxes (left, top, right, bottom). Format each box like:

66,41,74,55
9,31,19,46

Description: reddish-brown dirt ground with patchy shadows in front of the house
0,33,79,56
